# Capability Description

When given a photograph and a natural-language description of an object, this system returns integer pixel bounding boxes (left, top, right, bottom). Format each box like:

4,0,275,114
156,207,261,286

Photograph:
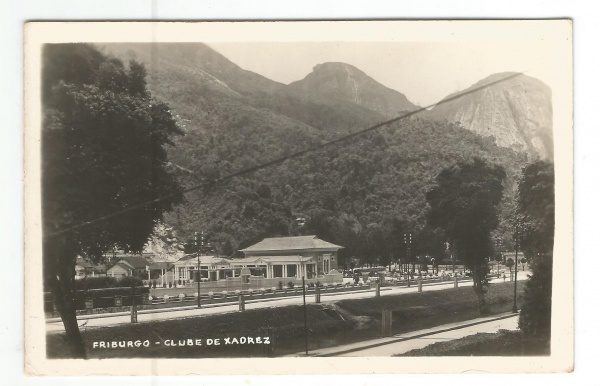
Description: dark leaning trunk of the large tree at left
44,238,86,359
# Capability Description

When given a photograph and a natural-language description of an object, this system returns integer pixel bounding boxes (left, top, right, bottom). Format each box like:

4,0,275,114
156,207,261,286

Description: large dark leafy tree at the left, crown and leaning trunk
41,44,183,358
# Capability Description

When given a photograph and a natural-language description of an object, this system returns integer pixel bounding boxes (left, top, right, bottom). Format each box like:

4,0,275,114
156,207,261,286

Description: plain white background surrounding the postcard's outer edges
0,0,600,385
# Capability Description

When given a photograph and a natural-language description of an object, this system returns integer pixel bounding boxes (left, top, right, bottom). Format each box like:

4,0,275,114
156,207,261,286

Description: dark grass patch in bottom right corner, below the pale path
399,330,550,357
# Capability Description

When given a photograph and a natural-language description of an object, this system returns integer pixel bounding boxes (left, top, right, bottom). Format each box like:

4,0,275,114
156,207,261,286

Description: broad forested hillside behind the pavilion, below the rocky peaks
104,44,527,262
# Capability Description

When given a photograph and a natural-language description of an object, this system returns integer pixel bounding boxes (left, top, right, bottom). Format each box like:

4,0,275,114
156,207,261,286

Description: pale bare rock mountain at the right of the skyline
428,73,554,160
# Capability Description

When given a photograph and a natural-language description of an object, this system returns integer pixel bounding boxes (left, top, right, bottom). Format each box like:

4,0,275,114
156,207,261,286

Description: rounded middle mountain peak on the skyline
288,62,419,118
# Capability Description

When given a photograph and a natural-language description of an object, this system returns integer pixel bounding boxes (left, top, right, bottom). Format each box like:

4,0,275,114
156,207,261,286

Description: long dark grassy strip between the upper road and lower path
46,283,523,358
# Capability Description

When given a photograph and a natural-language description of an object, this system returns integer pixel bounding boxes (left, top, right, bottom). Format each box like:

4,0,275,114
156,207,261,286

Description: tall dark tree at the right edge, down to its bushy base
517,161,554,341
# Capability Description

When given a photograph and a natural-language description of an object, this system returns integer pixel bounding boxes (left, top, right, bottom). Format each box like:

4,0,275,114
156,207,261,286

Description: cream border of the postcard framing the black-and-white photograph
25,20,573,375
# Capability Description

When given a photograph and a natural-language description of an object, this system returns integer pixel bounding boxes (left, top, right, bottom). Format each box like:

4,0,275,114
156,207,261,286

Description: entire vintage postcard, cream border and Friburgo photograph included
24,20,574,375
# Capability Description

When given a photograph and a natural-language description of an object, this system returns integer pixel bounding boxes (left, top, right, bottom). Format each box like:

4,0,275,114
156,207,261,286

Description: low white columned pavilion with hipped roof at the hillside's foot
145,236,343,297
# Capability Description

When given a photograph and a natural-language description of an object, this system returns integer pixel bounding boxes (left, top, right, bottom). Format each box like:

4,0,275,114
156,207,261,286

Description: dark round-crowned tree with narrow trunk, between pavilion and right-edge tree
426,158,506,314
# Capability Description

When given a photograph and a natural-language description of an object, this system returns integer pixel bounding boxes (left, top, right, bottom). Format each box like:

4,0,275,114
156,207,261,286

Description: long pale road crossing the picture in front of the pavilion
46,274,527,333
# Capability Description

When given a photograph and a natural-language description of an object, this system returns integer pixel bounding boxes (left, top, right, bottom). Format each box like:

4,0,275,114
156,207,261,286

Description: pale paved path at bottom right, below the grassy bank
288,312,519,357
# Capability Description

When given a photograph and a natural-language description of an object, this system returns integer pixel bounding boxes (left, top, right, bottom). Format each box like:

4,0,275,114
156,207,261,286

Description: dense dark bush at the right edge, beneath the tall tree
519,256,552,339
